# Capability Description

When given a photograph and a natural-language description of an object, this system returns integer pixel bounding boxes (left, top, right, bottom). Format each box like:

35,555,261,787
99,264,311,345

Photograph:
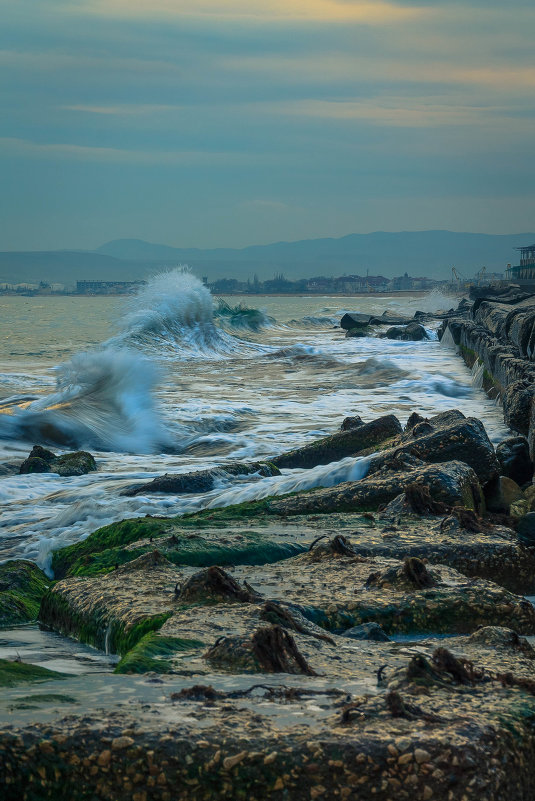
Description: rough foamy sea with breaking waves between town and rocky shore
0,268,507,576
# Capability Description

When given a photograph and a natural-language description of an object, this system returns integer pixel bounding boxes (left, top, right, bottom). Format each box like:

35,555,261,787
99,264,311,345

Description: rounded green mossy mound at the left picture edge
0,560,50,627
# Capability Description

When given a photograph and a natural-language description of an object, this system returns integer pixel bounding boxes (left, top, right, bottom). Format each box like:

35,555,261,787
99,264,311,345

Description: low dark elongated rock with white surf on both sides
121,462,280,497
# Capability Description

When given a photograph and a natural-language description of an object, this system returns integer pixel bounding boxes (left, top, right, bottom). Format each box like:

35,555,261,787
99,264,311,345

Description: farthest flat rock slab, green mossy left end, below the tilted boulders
54,507,535,594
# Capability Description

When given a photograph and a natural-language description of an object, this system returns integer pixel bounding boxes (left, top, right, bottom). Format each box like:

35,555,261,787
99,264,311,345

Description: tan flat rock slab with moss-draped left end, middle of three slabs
40,543,535,664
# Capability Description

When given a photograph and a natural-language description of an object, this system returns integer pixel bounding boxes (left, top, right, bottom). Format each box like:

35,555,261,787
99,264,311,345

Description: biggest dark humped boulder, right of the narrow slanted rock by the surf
368,411,499,485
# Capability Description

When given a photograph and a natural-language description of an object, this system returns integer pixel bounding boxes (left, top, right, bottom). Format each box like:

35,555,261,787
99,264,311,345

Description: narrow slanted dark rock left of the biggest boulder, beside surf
271,414,401,468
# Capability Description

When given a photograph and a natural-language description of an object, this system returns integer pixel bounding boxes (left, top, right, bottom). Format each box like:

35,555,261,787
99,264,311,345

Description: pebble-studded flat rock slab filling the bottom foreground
0,640,535,801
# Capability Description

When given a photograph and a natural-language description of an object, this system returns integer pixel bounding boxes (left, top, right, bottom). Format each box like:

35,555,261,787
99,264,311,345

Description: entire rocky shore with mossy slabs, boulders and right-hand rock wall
0,298,535,801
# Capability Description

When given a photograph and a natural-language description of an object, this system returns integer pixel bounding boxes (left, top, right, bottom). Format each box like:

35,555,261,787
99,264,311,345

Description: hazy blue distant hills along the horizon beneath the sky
0,231,535,284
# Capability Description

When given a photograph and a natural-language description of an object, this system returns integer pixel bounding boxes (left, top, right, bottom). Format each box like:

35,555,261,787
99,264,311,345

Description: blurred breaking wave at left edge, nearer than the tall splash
0,347,170,453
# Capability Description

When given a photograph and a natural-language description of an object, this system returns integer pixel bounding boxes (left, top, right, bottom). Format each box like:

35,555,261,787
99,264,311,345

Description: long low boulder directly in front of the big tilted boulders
269,461,484,515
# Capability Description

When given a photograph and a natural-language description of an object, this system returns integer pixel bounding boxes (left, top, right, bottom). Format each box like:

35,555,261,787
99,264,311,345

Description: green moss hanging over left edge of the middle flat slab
39,591,171,656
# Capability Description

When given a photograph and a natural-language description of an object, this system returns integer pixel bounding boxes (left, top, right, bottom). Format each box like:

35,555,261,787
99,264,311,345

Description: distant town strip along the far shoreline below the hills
0,267,504,296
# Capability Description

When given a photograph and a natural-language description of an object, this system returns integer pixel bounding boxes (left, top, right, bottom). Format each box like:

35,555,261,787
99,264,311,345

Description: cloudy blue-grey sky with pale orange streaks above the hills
0,0,535,250
